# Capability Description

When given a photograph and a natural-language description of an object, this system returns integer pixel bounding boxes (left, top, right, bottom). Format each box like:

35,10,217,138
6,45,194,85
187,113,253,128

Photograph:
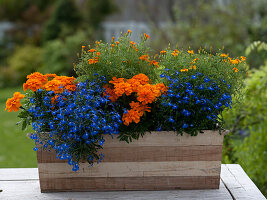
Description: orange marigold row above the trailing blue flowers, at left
23,72,76,93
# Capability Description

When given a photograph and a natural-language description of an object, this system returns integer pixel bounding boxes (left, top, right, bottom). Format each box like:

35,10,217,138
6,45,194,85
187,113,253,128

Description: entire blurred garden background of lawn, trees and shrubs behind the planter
0,0,267,196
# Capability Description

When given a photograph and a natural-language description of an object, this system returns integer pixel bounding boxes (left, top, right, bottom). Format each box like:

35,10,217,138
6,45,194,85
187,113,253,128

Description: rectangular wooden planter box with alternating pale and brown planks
37,131,227,192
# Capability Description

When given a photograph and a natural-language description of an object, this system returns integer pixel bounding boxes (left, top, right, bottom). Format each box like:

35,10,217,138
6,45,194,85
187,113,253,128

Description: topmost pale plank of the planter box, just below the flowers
104,131,224,148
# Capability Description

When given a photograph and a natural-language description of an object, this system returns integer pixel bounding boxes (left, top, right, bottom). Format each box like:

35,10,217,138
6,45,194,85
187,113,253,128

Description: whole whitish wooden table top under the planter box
0,164,266,200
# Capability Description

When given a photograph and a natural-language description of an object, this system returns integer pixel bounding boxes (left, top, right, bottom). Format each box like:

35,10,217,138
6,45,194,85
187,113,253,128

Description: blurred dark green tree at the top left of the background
43,0,81,41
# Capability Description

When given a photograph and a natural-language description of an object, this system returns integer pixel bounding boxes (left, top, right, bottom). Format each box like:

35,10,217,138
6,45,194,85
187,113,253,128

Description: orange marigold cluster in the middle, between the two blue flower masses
104,74,167,126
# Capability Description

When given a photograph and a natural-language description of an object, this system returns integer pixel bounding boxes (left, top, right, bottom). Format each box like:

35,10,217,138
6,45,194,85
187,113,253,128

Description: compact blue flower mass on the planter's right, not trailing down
158,69,232,135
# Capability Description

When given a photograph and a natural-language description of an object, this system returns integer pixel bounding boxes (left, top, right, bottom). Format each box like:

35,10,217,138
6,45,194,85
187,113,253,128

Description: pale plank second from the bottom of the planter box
38,161,221,179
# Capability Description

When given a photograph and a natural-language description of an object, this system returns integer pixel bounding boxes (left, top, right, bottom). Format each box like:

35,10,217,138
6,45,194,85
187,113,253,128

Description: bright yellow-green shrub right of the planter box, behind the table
224,65,267,195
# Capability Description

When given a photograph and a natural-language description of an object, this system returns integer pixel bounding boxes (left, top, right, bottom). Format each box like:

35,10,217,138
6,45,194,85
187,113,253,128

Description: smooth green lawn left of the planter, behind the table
0,88,37,168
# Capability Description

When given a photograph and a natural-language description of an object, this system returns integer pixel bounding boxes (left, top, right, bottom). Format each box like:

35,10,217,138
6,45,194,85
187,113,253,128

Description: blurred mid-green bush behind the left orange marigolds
39,32,89,75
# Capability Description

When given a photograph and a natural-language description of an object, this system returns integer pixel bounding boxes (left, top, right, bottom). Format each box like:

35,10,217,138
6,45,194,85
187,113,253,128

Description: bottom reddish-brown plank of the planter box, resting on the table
38,176,220,192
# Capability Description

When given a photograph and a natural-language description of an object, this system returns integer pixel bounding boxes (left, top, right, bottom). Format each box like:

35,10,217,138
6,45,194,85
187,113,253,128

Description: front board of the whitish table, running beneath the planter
0,180,232,200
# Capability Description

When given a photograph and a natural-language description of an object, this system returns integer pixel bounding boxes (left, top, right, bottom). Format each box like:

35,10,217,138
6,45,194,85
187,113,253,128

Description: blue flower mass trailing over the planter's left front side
28,77,122,171
